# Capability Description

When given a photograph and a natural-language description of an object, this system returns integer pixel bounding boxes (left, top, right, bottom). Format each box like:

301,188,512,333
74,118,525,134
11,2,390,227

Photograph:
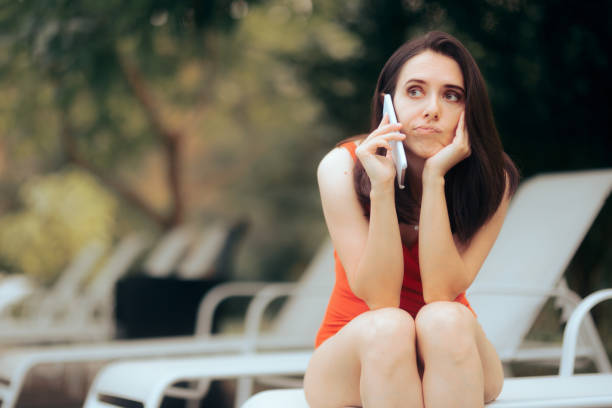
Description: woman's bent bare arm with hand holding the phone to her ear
317,118,404,309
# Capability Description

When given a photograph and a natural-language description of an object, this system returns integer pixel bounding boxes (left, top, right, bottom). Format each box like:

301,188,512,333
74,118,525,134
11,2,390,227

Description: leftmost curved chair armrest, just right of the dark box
196,282,271,336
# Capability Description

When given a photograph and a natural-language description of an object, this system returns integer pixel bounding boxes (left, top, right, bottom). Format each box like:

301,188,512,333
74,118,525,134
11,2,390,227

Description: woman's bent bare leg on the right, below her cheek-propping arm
415,302,503,408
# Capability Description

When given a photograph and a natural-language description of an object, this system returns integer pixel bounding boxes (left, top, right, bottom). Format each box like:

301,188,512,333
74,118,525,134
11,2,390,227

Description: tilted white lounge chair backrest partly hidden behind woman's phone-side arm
273,240,335,345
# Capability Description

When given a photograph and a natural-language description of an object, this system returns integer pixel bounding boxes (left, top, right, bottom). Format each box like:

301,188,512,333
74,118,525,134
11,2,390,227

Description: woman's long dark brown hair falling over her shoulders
346,31,519,243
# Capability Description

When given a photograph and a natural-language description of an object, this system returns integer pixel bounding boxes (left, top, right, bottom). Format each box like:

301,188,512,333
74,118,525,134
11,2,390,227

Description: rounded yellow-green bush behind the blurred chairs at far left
0,169,117,283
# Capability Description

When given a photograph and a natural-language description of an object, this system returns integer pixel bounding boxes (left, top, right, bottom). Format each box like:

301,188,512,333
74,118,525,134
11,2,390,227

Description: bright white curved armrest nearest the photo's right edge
559,289,612,376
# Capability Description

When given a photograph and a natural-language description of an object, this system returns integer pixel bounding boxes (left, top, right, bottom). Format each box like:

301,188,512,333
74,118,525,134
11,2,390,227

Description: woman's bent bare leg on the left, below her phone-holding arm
304,308,423,408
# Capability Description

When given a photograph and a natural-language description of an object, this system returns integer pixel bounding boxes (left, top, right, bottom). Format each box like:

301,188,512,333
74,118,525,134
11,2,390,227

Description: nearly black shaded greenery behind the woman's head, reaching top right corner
296,0,612,176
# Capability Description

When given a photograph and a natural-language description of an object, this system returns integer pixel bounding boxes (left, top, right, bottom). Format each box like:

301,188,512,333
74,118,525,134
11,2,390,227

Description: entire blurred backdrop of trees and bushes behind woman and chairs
0,0,612,348
